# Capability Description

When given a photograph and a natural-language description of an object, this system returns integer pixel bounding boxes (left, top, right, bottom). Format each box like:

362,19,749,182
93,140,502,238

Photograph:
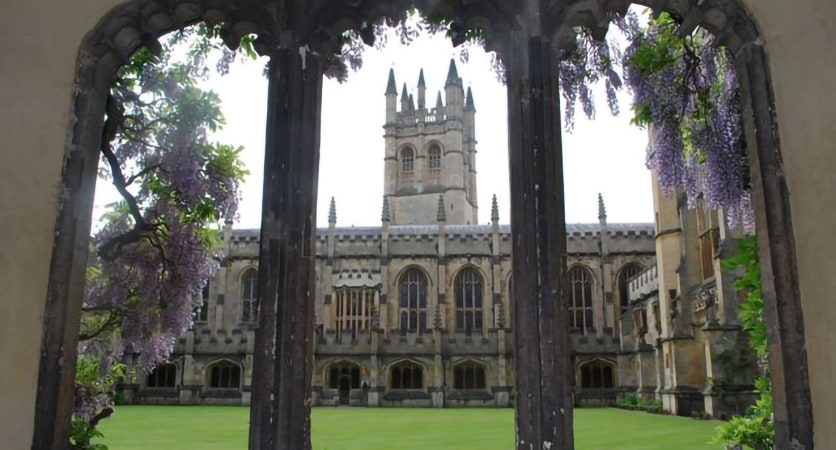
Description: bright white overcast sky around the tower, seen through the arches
95,29,653,228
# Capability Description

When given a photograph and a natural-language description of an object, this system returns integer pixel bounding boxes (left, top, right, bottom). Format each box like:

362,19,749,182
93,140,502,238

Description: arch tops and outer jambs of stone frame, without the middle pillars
33,0,812,448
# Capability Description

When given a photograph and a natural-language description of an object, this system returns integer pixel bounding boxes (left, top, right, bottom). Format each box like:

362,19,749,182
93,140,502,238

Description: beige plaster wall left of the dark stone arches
0,0,122,449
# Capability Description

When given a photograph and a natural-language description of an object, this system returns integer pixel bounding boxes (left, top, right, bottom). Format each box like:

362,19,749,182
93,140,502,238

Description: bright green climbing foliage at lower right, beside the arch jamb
714,236,775,450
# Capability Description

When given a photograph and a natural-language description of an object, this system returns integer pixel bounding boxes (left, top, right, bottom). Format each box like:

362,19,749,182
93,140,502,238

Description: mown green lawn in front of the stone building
96,406,720,450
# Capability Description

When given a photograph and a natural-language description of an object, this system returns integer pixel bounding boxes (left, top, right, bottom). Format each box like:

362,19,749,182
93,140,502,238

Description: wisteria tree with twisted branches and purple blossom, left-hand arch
71,26,254,448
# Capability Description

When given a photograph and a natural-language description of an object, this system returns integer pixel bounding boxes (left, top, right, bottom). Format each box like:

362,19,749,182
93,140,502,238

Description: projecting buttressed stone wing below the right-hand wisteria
618,169,759,418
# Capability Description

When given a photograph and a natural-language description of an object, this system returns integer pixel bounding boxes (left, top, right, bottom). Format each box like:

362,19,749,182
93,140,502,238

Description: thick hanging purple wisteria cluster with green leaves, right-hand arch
623,14,752,228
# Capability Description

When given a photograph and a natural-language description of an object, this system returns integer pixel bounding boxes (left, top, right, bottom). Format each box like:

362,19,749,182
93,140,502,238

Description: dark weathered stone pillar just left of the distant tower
249,48,323,450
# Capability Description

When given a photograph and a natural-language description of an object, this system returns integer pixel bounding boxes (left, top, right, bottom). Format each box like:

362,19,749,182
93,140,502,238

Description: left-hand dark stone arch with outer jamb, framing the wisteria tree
33,4,277,448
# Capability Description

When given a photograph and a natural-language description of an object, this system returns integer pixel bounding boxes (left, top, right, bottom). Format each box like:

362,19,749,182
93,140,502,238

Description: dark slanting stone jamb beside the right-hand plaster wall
735,45,812,449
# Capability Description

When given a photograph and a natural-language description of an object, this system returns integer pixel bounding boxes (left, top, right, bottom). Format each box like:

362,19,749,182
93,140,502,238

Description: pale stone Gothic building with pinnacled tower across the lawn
127,61,751,415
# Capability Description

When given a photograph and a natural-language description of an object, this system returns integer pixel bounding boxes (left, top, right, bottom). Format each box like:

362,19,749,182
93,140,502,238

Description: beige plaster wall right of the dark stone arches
744,0,836,442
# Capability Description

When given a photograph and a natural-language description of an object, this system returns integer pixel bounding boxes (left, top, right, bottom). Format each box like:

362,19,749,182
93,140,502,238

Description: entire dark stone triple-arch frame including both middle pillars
33,0,812,449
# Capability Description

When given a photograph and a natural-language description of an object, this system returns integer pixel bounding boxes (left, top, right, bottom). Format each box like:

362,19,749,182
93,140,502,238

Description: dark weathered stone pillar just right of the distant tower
503,33,574,450
